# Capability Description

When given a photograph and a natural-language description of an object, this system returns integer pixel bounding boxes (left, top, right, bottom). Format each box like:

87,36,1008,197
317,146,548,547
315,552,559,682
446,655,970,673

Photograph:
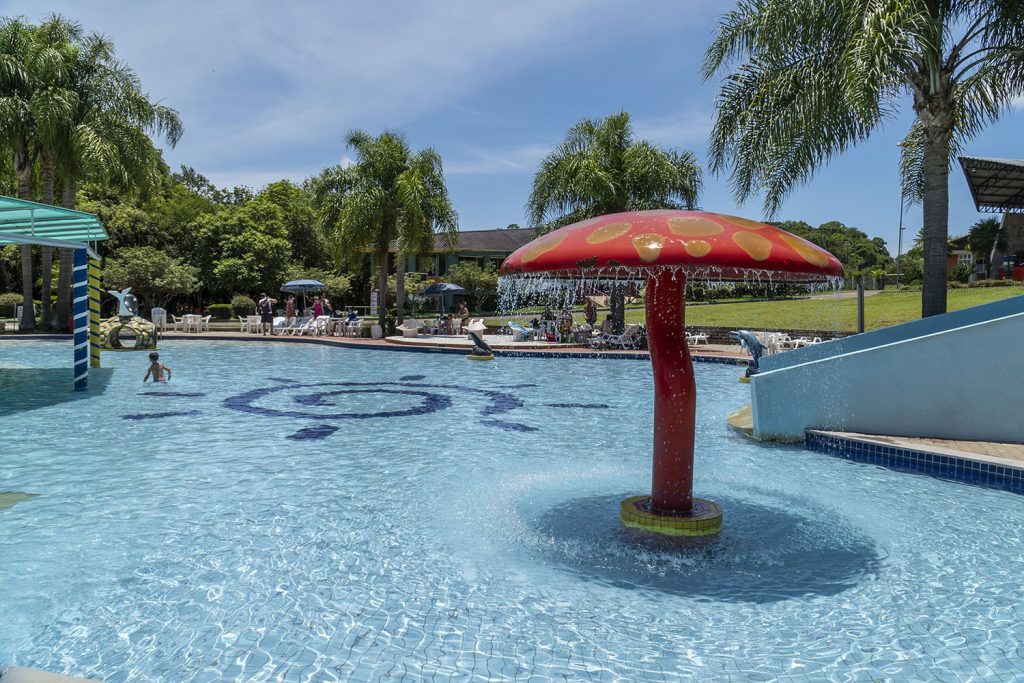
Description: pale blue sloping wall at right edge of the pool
751,312,1024,443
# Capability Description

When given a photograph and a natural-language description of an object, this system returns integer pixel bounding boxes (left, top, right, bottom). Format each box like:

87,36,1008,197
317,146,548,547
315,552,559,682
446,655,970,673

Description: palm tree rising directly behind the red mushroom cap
526,112,700,331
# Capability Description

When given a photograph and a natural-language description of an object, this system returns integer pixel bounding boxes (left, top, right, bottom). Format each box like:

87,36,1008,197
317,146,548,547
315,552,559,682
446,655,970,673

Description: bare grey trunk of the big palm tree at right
921,133,949,317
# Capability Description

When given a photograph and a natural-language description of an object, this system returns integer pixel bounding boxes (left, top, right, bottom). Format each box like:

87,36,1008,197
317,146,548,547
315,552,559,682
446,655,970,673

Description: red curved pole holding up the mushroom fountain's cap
646,269,697,514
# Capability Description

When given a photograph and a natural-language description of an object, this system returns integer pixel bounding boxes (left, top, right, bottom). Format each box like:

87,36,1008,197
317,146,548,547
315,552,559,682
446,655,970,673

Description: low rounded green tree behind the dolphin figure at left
103,247,199,309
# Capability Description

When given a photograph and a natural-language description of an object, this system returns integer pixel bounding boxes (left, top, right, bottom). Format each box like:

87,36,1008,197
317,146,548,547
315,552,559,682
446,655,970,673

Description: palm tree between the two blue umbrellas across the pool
313,130,459,327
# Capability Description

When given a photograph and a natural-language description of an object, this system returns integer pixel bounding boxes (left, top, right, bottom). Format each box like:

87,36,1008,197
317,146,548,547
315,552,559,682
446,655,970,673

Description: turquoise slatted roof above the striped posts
0,196,110,258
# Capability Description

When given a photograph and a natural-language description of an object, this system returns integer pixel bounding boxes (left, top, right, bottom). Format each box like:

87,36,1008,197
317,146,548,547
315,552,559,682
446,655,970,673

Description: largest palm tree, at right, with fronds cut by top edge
703,0,1024,315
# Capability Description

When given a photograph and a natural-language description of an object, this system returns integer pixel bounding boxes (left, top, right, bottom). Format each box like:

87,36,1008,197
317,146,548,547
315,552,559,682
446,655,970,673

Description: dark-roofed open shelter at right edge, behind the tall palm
959,157,1024,280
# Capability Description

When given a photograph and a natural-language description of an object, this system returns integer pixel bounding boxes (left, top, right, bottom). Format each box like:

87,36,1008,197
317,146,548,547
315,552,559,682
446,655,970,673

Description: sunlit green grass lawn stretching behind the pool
486,287,1024,332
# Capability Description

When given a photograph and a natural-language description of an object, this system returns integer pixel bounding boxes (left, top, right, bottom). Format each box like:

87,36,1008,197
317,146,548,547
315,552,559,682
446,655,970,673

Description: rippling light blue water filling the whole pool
0,342,1024,681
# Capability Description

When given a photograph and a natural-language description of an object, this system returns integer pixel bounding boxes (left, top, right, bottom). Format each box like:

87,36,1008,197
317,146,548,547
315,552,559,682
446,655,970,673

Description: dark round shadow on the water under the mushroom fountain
523,494,884,603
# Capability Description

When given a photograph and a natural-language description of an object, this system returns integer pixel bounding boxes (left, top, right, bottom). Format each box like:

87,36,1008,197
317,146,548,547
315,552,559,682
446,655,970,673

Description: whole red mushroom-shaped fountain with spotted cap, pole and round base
500,209,843,537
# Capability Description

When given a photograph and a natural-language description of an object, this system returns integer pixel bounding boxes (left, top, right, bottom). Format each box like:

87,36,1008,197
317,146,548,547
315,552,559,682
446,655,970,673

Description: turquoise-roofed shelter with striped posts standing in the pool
0,196,110,390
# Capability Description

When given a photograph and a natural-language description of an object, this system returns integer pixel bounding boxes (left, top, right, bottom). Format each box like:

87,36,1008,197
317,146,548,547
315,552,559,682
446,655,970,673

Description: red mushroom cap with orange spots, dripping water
501,209,843,282
